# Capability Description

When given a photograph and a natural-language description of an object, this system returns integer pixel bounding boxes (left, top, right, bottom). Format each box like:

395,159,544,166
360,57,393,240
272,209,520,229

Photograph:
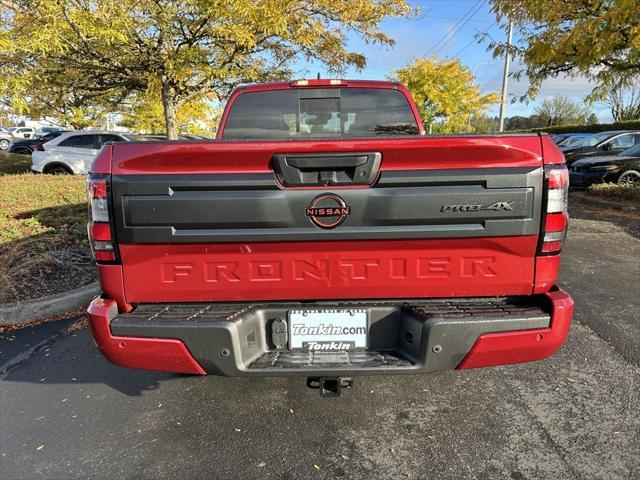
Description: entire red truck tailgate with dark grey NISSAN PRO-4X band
111,136,543,303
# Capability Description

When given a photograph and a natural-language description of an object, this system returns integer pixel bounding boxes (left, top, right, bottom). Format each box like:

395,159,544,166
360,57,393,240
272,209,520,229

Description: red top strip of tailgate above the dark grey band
112,135,542,176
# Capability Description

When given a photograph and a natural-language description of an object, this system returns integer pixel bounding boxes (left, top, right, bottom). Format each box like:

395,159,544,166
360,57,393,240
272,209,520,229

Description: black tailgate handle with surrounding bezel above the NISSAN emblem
273,152,382,187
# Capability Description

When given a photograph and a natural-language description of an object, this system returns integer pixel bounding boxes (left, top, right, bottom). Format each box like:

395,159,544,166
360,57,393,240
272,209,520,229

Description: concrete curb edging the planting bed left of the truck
0,282,101,325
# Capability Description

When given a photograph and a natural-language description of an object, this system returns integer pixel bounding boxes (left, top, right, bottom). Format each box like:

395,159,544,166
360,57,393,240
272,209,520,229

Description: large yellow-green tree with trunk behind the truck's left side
0,0,412,138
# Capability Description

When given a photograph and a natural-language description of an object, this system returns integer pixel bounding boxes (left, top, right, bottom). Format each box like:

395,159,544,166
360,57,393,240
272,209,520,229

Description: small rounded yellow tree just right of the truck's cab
392,57,498,133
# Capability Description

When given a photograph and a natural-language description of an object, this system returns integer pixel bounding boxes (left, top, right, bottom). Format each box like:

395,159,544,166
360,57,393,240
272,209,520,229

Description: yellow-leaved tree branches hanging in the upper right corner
490,0,640,98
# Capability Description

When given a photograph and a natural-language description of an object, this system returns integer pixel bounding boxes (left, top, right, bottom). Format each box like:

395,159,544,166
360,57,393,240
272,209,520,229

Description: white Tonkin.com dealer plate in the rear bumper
289,309,369,351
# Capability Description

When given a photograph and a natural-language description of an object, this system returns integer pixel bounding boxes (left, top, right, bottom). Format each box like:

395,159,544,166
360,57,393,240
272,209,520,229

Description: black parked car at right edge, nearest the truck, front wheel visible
569,144,640,188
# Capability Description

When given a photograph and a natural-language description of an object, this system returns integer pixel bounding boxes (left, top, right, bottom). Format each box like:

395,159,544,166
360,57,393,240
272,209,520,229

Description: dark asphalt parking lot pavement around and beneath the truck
0,203,640,480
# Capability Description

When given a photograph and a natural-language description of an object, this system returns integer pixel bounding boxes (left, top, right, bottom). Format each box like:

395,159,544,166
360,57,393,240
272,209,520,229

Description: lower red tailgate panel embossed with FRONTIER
120,236,538,303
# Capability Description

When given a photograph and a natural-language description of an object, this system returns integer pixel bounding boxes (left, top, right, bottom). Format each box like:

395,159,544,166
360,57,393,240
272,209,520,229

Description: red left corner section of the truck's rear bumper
87,298,206,375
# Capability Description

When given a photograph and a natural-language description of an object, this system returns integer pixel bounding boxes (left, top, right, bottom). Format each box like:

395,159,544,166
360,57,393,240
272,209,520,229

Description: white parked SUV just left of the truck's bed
31,131,136,174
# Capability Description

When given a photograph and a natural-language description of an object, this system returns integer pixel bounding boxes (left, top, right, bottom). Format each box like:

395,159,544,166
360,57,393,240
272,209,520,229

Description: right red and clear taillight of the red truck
538,165,569,255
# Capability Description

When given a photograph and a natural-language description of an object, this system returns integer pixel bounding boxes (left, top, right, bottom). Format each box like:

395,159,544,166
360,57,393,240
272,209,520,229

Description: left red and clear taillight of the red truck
87,175,116,263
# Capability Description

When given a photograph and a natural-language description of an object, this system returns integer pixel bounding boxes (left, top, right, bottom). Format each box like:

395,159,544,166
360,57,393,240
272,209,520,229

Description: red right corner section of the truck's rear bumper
457,290,573,369
